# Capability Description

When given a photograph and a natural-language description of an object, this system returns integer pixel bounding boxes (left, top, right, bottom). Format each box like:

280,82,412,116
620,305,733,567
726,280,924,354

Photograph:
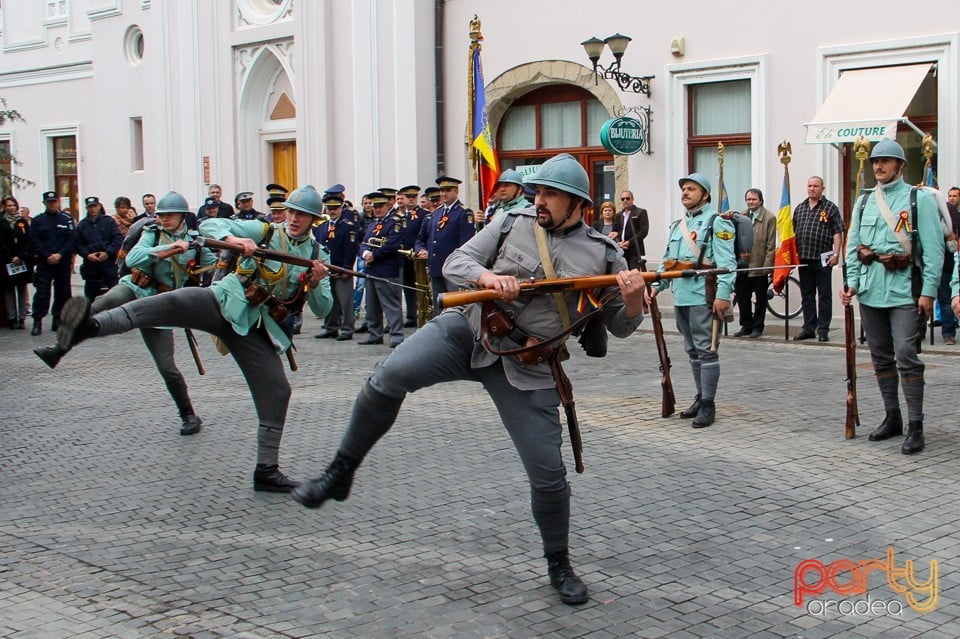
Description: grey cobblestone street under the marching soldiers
0,302,960,639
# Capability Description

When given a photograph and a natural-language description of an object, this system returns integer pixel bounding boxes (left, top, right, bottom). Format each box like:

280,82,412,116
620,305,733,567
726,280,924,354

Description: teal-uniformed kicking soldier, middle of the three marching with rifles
50,186,333,492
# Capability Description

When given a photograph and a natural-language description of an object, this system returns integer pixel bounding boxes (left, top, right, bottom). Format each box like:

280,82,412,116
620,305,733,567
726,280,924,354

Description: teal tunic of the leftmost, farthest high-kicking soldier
120,224,217,298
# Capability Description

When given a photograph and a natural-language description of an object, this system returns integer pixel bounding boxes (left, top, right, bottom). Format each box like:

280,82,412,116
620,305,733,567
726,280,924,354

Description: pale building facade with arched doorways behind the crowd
0,0,960,255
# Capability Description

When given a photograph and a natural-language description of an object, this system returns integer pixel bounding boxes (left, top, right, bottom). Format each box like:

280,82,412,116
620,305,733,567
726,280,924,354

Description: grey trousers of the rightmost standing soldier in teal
860,304,925,422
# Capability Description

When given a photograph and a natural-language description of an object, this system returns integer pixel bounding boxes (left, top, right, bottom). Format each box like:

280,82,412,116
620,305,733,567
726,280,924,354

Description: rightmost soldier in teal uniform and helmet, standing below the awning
840,140,940,455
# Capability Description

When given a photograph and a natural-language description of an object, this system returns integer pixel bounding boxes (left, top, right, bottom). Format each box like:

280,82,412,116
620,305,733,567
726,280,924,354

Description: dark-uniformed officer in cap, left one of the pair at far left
30,191,76,335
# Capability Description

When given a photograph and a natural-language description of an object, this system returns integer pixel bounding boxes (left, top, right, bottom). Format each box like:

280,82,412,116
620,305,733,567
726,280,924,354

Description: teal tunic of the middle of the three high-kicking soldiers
200,218,333,354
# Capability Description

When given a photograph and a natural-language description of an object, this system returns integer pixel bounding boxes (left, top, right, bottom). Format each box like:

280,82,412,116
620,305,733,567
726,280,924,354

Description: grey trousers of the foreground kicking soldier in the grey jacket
358,312,570,553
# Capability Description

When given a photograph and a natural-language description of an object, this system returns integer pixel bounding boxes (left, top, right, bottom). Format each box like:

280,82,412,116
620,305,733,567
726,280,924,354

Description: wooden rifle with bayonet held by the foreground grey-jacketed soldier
440,265,784,308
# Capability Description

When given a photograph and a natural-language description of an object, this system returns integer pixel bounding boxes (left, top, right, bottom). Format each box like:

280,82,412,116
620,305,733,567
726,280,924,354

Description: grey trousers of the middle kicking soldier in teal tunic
96,287,290,465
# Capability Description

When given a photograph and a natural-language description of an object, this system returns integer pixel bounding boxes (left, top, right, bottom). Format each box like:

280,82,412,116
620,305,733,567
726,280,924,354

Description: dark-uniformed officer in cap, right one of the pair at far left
77,195,123,302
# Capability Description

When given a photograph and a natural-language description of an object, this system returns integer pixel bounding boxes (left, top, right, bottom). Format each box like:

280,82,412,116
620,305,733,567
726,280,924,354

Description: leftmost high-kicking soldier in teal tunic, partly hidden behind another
33,191,217,435
